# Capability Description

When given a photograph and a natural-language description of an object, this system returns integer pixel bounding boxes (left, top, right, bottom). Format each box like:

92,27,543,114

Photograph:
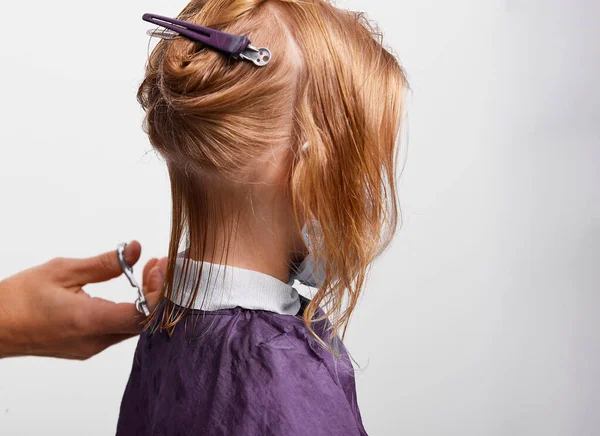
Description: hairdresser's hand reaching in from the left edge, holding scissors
0,241,166,359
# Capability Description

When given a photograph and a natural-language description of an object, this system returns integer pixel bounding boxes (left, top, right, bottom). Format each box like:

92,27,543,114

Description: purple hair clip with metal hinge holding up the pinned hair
142,14,272,67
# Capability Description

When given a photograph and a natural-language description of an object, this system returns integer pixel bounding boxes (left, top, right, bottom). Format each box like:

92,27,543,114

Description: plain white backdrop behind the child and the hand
0,0,600,436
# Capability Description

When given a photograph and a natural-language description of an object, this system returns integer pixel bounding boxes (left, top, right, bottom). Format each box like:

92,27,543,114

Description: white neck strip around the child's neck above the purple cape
171,255,300,315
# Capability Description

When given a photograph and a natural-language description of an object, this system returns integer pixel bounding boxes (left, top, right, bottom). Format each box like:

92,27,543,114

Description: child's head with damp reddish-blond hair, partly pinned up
138,0,407,340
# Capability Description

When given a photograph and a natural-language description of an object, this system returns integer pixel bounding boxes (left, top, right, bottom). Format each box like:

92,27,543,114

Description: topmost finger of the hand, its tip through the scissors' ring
67,241,142,286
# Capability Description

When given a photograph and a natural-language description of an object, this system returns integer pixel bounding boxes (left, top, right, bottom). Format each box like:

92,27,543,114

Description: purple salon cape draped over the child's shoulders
117,258,367,436
